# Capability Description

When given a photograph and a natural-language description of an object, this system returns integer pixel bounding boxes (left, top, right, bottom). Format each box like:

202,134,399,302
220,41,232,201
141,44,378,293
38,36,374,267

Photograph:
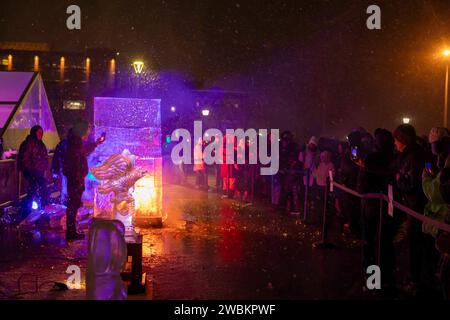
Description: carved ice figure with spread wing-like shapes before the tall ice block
92,150,147,229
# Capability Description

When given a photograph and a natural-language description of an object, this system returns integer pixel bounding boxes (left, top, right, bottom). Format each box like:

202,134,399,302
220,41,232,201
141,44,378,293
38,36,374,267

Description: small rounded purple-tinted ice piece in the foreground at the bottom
86,220,127,300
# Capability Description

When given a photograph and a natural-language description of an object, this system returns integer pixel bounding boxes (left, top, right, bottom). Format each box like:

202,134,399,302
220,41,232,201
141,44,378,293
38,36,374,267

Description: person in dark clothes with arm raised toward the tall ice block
63,121,105,241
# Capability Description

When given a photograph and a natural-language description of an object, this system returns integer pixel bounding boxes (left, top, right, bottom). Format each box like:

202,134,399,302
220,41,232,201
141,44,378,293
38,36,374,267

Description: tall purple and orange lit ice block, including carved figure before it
93,98,162,228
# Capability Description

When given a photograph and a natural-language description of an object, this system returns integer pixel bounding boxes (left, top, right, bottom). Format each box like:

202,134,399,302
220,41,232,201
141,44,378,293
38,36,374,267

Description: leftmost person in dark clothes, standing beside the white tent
18,126,49,216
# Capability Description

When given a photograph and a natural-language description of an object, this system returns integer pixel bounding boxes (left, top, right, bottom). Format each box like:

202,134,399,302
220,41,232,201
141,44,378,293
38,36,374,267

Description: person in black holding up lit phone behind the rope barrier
358,129,396,288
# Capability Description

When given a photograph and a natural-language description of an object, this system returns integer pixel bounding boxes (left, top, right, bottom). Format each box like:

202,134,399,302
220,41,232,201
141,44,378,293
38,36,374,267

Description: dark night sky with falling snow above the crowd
0,0,450,137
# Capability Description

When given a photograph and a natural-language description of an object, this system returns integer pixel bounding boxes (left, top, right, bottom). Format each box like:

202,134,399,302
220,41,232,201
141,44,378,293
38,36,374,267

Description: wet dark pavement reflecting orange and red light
0,180,412,300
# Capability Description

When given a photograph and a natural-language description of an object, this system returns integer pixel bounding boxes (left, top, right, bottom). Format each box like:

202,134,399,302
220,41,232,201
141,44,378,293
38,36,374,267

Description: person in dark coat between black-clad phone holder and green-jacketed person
394,124,427,293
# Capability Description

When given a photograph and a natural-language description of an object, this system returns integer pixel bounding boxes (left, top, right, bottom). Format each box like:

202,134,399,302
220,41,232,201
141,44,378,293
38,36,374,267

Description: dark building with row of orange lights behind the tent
0,42,118,135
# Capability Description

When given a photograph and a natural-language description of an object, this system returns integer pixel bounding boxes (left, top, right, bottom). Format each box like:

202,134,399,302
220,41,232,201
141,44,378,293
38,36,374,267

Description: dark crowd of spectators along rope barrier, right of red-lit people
253,124,450,298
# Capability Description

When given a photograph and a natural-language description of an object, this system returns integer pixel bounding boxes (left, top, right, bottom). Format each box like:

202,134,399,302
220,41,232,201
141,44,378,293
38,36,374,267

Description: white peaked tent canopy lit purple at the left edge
0,72,59,150
